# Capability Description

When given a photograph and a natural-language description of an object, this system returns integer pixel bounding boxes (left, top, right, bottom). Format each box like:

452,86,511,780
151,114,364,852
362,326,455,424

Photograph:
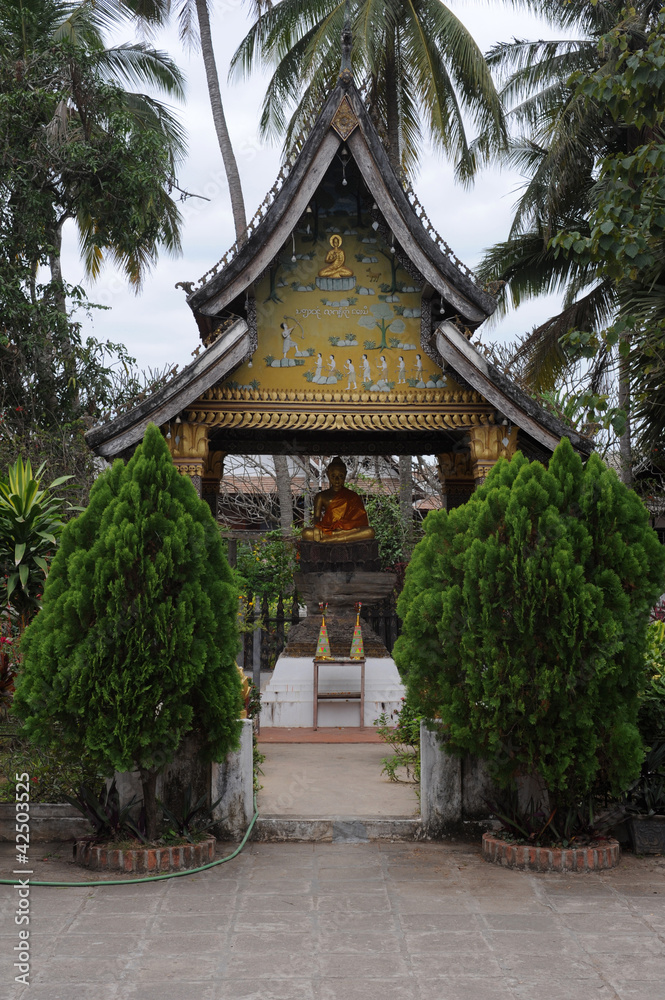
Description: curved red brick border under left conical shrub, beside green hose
74,837,217,875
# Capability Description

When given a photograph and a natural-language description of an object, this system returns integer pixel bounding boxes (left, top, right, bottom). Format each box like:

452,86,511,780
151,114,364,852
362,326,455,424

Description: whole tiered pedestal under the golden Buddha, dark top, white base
261,540,405,727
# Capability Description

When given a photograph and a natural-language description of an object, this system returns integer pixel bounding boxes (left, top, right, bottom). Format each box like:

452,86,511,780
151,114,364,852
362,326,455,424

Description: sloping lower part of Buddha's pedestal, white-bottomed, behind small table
261,608,405,728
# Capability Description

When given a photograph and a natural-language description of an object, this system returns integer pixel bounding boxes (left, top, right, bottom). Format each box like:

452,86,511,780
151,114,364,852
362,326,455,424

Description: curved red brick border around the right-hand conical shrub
483,833,621,872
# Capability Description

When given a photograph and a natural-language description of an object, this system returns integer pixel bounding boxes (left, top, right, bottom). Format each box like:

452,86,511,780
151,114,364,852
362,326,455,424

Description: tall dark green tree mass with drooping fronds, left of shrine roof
0,0,184,494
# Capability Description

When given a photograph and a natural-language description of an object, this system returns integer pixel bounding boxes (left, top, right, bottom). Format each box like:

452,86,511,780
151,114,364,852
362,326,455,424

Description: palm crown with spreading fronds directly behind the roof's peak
231,0,505,179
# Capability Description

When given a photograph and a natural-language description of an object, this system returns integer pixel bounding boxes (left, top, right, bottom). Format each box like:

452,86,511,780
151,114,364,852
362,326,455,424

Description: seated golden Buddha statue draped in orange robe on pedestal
302,456,374,542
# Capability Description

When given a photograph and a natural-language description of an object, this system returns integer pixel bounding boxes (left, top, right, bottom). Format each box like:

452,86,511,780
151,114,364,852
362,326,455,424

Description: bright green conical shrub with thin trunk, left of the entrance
14,425,242,838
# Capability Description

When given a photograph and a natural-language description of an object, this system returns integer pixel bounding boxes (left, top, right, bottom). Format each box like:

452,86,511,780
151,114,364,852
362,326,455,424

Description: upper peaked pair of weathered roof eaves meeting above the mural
187,82,496,327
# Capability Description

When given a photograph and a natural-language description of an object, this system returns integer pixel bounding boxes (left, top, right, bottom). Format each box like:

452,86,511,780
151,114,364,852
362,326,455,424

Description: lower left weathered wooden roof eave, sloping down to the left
85,319,251,460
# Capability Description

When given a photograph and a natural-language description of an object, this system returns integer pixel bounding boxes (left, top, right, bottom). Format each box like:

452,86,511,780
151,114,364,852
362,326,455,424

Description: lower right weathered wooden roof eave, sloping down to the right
436,320,593,457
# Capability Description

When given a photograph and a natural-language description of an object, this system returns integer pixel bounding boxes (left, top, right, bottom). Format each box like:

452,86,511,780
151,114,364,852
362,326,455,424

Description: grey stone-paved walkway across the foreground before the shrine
0,843,665,1000
